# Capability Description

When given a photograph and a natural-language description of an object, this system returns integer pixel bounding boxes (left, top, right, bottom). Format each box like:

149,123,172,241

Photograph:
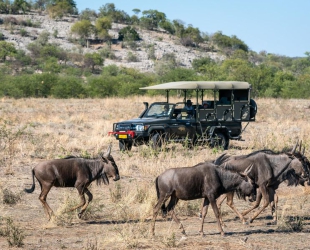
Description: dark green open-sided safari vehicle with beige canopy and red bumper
109,81,257,151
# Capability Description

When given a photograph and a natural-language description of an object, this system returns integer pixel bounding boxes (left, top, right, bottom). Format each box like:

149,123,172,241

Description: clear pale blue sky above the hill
75,0,310,57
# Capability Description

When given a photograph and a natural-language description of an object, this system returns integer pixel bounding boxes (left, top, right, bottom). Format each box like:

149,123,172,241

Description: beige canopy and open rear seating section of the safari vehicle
140,81,257,122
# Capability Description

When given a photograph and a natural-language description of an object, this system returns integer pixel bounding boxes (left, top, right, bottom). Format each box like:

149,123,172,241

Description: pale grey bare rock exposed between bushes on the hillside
0,13,224,72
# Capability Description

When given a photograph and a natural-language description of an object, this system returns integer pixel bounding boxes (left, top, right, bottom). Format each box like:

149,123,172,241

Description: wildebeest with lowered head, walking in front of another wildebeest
151,162,255,235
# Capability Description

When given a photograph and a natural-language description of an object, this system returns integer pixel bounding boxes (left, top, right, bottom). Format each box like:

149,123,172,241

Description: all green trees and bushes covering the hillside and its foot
0,0,310,98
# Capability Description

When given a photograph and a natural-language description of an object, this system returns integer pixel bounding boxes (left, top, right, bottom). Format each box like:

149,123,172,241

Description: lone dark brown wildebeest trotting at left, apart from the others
25,145,120,220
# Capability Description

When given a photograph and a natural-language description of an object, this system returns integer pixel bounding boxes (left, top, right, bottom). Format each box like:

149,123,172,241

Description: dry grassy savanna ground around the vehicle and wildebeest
0,97,310,249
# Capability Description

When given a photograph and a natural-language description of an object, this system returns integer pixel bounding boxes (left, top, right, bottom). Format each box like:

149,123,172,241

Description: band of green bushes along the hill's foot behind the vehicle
0,56,310,99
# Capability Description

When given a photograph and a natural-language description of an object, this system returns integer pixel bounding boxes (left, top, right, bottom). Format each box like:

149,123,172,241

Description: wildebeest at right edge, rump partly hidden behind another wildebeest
215,144,309,223
